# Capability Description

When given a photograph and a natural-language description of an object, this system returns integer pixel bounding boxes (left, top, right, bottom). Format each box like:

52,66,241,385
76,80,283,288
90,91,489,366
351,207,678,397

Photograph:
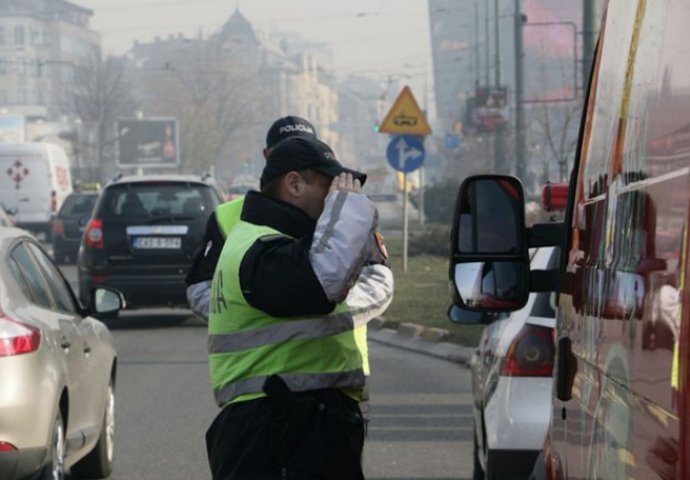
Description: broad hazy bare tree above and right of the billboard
133,44,266,176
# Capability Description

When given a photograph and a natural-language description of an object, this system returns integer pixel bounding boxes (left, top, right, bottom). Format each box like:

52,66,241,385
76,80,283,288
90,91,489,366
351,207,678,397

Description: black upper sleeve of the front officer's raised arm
240,236,336,317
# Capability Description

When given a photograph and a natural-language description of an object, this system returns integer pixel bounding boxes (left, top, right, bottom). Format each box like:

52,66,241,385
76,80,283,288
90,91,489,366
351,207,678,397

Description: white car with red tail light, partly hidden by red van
470,247,558,480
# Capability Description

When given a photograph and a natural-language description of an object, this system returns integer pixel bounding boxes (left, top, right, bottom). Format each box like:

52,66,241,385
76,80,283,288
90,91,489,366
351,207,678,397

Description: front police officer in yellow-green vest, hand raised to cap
206,136,378,480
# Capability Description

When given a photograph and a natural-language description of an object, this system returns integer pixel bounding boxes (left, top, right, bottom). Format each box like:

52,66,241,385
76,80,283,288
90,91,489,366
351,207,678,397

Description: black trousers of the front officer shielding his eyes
206,389,364,480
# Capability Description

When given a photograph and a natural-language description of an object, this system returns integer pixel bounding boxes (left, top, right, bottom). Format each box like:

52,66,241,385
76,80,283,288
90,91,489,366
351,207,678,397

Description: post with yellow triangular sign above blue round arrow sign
379,86,431,273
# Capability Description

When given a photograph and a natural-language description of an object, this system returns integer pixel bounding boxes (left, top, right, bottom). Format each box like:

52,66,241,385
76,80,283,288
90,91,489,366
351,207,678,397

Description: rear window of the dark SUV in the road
103,182,215,218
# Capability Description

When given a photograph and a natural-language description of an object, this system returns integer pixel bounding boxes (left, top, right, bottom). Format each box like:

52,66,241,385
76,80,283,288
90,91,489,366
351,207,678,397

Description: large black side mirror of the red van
449,175,530,312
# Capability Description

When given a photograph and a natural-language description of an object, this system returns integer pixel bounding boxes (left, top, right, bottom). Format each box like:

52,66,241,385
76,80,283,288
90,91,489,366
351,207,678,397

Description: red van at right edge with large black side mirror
450,0,690,480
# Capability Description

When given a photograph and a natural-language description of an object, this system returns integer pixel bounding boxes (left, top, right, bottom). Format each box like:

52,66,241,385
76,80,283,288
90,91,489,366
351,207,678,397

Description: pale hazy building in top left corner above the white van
0,0,100,120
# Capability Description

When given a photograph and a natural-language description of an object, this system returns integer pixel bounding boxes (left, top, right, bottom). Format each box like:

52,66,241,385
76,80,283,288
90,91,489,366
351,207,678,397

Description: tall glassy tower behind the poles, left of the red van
428,0,603,187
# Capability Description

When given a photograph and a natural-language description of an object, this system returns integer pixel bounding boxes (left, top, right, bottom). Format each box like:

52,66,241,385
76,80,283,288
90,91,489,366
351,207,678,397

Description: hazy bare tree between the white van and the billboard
72,52,136,180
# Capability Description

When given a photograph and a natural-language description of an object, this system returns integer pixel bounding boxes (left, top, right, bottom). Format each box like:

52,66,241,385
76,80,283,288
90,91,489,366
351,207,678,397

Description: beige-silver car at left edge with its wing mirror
0,227,123,480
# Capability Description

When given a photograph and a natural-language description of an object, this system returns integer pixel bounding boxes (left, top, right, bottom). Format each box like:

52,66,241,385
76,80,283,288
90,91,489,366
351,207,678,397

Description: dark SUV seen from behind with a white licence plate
77,175,223,308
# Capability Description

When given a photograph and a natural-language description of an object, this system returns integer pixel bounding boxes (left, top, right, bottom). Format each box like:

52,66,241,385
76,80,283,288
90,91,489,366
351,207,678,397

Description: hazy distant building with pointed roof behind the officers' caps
128,9,339,183
